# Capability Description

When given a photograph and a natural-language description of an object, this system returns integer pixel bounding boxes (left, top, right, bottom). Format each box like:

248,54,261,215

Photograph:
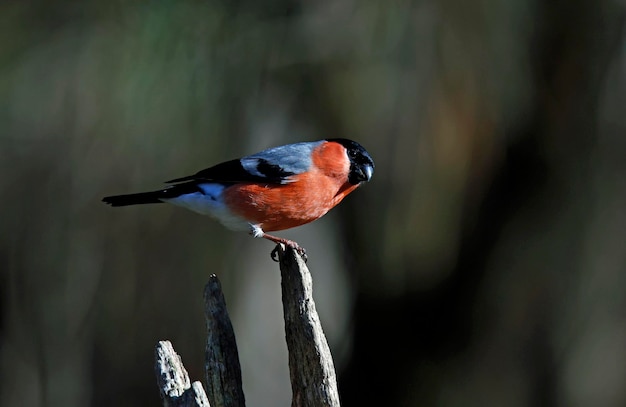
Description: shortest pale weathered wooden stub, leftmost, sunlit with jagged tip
155,341,210,407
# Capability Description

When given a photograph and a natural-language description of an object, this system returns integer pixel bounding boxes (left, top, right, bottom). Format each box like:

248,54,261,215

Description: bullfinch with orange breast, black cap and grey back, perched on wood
102,138,374,259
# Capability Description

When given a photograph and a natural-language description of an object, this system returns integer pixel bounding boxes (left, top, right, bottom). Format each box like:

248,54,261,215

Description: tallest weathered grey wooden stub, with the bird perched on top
278,246,339,407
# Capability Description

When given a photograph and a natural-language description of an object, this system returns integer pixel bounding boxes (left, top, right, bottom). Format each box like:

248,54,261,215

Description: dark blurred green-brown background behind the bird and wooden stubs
0,0,626,407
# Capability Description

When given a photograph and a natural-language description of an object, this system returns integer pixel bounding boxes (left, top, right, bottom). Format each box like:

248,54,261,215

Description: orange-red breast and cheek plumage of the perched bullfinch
224,143,357,232
